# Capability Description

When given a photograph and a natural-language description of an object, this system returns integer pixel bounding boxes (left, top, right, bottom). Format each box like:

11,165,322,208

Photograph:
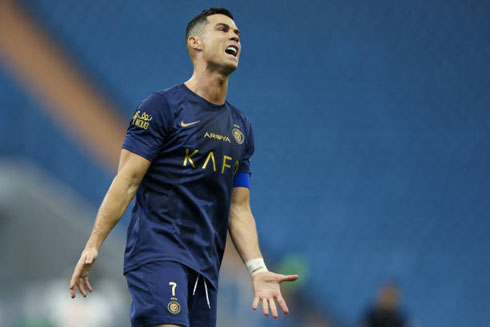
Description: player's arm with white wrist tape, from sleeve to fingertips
229,187,298,318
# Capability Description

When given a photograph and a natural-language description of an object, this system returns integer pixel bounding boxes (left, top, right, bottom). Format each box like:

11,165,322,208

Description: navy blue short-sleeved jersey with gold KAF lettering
123,84,254,287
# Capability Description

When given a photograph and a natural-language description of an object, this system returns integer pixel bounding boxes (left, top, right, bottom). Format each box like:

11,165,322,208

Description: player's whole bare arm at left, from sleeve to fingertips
70,149,151,298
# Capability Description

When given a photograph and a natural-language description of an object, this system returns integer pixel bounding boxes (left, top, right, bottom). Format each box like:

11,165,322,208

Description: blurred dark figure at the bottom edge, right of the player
364,283,408,327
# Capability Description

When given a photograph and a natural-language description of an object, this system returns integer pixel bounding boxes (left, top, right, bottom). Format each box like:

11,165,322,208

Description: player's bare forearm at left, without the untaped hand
85,175,138,250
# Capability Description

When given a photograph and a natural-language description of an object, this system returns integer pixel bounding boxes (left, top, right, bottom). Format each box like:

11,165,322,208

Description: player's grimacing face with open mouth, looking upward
201,14,241,74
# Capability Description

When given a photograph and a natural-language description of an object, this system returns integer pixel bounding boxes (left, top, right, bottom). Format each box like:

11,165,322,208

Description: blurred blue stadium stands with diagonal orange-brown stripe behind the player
0,0,490,327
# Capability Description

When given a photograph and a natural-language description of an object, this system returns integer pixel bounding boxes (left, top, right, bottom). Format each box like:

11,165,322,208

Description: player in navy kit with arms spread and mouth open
70,8,298,327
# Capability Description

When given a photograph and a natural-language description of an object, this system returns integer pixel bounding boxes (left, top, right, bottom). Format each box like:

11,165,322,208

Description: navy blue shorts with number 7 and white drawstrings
125,261,217,327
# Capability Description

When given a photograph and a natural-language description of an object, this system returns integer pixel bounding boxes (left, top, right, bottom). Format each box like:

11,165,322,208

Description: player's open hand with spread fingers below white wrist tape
252,271,298,318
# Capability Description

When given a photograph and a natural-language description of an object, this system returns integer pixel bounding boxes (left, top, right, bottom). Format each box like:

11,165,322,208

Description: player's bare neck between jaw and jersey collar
184,67,228,105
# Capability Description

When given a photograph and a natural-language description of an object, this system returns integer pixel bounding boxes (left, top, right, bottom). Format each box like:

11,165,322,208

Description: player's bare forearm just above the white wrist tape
229,206,262,262
